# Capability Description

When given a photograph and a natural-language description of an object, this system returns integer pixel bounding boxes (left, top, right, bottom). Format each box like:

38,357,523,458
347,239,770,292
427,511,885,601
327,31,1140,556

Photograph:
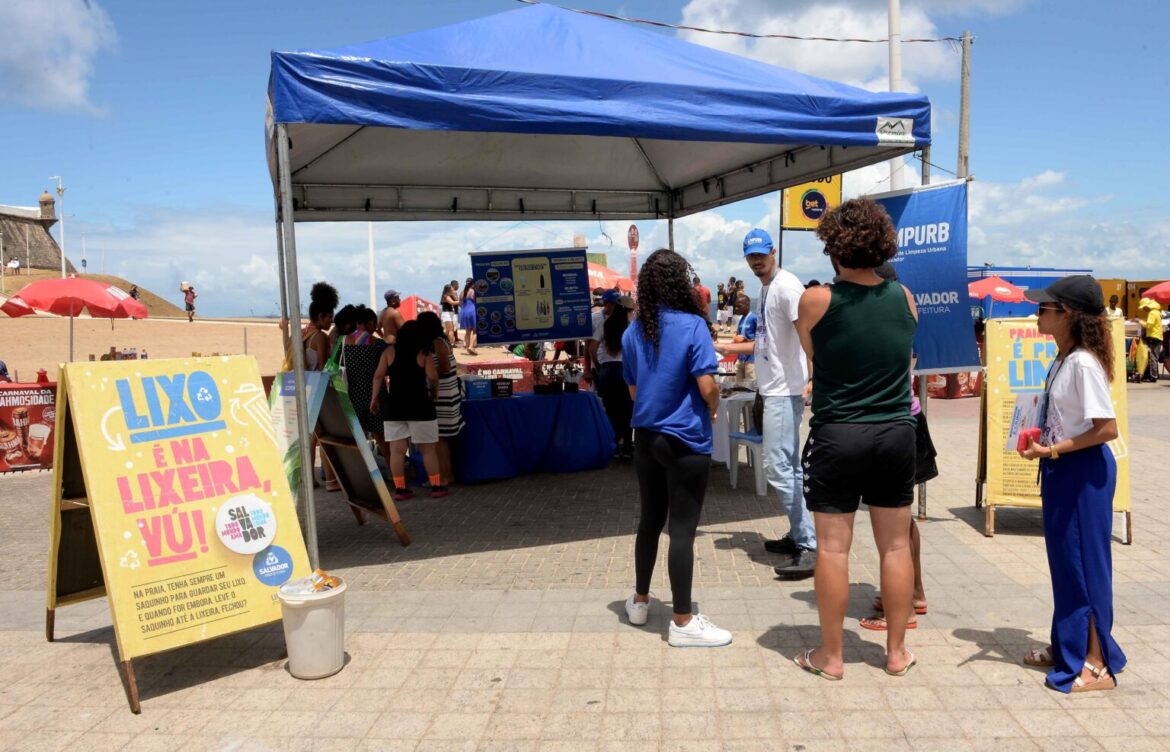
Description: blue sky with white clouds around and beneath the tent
0,0,1170,315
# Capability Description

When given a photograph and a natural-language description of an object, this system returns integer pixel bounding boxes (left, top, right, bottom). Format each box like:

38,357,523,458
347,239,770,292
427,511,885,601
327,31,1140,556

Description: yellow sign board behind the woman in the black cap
983,317,1129,512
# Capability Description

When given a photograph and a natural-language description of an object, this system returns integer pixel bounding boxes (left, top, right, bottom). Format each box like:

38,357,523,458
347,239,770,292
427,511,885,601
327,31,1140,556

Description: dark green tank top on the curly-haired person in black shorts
808,280,917,426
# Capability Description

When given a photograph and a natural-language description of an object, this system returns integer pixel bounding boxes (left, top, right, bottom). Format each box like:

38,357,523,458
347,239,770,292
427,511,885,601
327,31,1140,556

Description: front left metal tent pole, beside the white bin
276,124,321,568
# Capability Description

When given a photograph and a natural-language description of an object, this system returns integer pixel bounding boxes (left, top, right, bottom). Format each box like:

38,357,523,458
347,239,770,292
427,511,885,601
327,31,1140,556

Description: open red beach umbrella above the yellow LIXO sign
0,277,149,360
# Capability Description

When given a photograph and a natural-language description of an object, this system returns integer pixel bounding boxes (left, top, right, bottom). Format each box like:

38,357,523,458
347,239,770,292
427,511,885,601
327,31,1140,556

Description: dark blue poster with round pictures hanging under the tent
472,248,593,345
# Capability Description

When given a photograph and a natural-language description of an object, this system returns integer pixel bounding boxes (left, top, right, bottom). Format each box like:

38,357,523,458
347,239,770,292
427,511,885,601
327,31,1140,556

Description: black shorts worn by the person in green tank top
801,422,917,513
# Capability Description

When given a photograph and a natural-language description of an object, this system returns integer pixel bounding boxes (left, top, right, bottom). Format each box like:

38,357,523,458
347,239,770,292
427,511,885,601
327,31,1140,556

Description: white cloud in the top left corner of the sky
0,0,117,112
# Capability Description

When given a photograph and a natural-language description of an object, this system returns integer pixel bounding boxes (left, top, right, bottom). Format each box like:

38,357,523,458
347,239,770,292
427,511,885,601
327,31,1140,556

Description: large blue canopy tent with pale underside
267,5,930,561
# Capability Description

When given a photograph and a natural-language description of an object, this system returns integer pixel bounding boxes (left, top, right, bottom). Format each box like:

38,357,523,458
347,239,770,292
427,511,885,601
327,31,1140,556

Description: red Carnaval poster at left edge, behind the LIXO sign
0,384,57,472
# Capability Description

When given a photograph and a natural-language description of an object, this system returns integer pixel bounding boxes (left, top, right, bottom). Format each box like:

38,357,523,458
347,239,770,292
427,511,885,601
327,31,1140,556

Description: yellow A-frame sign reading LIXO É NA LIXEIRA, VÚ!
49,357,310,661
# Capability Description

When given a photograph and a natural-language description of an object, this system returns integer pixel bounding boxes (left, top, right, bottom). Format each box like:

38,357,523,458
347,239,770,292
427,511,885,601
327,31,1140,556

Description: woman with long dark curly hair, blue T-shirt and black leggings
621,248,731,648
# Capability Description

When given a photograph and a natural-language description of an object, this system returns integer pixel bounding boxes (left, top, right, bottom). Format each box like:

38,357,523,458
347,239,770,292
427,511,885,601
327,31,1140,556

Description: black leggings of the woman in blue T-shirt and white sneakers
634,428,711,614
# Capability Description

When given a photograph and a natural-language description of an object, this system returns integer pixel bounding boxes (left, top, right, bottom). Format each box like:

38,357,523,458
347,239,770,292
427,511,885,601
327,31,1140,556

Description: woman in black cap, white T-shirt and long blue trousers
1020,275,1126,692
